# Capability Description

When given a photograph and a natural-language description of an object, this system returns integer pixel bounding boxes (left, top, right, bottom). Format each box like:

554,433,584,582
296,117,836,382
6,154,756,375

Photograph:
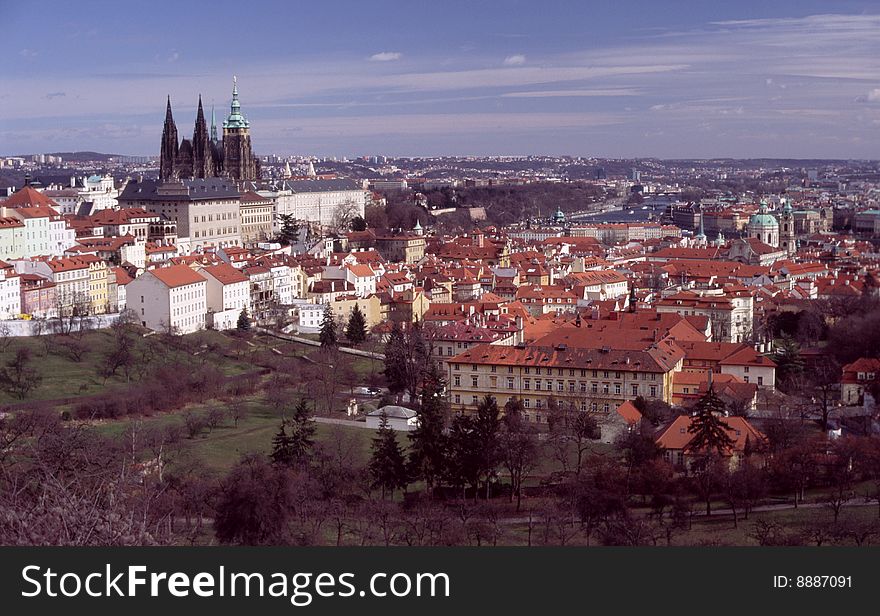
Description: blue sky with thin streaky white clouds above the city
0,0,880,158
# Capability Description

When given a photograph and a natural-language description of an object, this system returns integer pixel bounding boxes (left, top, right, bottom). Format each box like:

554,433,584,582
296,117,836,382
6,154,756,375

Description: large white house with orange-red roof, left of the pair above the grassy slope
126,265,208,334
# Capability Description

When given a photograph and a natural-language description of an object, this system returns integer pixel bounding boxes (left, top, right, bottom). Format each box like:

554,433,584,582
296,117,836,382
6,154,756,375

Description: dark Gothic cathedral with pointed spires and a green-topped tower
159,77,260,181
